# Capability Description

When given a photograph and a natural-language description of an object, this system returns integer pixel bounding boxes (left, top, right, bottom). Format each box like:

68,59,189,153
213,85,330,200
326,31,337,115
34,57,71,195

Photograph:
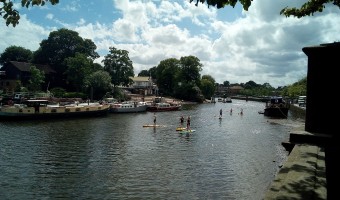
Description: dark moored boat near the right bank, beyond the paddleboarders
263,96,290,118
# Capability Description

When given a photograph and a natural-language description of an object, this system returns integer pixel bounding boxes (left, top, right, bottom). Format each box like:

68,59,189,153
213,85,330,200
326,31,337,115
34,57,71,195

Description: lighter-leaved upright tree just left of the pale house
102,47,134,87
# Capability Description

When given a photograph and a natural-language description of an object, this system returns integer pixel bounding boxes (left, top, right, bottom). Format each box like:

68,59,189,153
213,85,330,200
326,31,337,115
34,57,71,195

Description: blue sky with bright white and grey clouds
0,0,340,88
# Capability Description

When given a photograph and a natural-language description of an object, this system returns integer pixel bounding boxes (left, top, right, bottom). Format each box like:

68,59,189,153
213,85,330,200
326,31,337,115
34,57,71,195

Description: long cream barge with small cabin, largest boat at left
0,99,110,120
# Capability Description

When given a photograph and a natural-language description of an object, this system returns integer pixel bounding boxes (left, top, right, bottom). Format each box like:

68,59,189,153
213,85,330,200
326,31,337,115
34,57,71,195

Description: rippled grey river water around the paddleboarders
0,99,302,200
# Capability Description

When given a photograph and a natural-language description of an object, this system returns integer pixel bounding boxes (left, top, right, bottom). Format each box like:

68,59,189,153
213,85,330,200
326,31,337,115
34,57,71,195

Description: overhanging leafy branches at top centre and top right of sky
190,0,340,18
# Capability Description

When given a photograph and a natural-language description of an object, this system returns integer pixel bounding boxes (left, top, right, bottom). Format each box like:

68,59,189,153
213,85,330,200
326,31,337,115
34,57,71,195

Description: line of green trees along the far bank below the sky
0,28,302,102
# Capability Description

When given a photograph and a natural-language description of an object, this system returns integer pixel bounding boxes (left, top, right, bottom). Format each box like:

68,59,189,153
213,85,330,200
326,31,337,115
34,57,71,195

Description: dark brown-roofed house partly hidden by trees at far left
0,61,57,93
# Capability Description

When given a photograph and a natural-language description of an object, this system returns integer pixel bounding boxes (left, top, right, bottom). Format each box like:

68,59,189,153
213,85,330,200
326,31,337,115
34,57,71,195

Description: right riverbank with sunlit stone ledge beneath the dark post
264,104,339,200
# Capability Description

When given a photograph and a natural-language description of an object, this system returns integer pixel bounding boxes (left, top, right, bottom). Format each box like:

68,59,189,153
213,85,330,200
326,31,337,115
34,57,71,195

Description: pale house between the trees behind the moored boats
130,76,157,95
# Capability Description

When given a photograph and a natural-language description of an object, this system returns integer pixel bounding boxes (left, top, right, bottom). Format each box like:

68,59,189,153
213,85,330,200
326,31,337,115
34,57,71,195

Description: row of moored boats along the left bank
0,99,181,120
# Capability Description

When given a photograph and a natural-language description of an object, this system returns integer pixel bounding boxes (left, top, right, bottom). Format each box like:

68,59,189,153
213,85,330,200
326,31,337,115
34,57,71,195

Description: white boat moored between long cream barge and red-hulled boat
110,102,148,113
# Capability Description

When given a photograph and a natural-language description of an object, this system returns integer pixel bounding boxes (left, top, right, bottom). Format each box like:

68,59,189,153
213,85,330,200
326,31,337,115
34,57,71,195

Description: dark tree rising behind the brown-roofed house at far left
0,46,33,65
